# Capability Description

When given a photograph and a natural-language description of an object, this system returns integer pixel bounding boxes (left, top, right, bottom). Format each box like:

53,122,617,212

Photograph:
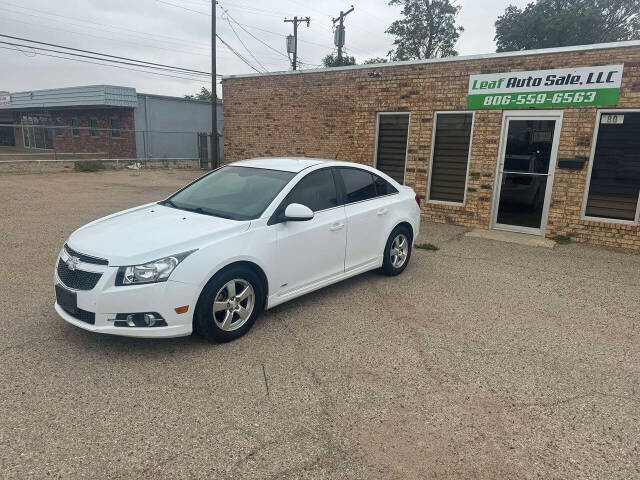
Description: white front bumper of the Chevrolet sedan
54,252,198,338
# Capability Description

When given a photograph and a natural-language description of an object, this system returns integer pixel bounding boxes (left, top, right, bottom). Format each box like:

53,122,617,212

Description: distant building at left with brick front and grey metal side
0,85,222,159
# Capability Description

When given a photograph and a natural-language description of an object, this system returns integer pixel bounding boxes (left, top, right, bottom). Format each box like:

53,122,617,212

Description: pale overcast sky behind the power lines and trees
0,0,528,96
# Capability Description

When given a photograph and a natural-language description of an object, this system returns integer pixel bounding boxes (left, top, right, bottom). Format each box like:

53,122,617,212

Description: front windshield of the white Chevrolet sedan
160,166,296,220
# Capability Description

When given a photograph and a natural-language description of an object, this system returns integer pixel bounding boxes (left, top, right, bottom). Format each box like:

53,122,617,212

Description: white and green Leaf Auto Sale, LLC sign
467,65,624,110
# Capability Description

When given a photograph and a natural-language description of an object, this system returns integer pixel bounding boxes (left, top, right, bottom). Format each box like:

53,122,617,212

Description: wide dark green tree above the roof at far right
495,0,640,52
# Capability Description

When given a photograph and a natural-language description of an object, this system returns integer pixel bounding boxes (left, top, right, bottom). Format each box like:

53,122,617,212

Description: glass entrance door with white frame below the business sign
493,112,561,235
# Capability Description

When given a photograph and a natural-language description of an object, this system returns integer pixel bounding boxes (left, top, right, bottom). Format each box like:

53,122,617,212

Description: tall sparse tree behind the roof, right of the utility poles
387,0,464,60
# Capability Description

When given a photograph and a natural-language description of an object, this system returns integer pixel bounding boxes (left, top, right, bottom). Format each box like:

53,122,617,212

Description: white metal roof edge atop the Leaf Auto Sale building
222,40,640,80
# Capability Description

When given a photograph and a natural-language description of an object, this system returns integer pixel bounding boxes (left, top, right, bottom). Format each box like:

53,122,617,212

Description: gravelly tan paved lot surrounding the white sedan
0,171,640,479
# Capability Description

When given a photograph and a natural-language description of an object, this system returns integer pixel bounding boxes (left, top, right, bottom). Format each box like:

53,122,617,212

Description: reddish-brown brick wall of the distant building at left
14,108,136,158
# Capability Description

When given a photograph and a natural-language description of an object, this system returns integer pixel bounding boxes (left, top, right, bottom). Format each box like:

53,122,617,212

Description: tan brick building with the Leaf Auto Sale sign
223,42,640,250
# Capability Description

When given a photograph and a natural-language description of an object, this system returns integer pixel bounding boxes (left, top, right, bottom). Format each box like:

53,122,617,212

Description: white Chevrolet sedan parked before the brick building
54,158,420,342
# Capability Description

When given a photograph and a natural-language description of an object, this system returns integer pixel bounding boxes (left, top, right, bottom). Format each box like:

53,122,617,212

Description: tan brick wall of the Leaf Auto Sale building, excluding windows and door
223,47,640,250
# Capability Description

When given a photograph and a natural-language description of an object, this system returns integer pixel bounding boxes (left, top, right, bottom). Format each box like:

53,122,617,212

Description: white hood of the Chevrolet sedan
67,203,251,266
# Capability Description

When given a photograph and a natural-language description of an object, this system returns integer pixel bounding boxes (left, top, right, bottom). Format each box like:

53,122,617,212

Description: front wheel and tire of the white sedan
194,267,265,343
